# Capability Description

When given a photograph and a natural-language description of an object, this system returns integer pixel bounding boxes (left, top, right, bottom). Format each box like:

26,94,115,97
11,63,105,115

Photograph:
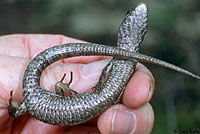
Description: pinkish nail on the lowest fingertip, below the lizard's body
111,106,136,134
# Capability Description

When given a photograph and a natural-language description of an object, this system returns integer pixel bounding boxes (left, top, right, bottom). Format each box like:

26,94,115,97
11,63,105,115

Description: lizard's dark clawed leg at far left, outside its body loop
8,91,27,118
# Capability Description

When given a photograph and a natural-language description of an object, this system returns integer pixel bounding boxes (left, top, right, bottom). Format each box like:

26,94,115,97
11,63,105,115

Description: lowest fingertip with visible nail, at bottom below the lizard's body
97,104,154,134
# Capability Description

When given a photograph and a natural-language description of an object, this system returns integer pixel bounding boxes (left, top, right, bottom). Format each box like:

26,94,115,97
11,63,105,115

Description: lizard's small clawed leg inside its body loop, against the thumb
55,72,78,96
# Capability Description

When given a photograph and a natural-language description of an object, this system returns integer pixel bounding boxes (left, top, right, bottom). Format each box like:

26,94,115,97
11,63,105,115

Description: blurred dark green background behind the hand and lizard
0,0,200,134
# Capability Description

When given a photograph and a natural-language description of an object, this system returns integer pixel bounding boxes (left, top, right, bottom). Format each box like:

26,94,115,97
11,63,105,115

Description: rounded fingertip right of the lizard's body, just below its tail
122,63,155,108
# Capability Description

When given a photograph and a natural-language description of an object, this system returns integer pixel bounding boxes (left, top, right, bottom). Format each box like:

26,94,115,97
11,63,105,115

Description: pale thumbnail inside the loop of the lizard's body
80,59,110,79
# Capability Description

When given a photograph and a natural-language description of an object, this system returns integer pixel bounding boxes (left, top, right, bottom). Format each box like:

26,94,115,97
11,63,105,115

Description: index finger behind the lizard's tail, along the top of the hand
0,34,108,63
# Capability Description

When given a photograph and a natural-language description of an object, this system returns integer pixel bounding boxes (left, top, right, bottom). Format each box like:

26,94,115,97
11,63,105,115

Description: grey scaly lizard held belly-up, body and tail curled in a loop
8,4,200,126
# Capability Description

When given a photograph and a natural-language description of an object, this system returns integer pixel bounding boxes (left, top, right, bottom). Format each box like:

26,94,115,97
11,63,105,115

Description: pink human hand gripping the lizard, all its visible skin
0,34,155,134
